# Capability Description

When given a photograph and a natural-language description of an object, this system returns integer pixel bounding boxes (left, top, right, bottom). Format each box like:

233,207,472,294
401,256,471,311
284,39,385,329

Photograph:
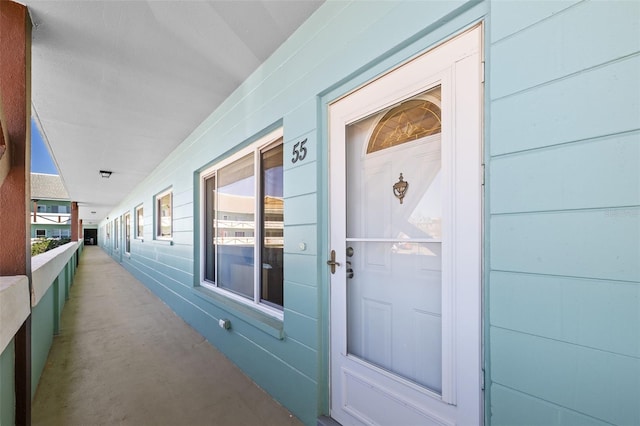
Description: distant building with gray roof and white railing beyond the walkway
30,173,71,238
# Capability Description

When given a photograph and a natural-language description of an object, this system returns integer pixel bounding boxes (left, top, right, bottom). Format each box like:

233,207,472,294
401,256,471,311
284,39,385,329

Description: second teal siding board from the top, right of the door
491,1,640,99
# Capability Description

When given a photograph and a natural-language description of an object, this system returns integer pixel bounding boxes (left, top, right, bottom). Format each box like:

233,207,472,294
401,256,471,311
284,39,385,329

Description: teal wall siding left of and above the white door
100,1,482,424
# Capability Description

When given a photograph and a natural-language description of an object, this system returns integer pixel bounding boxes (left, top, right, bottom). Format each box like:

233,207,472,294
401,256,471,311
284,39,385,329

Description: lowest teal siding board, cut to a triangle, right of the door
491,384,610,426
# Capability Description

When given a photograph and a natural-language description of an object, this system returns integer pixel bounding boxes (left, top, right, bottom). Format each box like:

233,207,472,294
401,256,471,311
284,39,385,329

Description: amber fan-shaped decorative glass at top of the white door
367,86,442,154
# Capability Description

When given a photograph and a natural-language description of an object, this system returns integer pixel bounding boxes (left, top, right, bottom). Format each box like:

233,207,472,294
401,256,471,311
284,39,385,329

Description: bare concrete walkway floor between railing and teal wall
32,247,301,426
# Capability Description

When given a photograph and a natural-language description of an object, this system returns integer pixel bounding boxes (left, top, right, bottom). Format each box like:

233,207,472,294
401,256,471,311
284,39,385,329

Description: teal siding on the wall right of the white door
485,1,640,425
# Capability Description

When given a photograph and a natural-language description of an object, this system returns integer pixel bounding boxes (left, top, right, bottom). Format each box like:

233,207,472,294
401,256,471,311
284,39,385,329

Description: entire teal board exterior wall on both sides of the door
99,1,640,424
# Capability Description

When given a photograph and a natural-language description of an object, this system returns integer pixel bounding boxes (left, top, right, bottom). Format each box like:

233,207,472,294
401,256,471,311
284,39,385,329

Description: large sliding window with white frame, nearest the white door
202,130,284,315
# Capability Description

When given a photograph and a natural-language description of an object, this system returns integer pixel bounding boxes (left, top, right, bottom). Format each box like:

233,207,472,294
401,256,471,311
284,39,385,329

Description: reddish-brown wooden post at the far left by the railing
0,0,31,425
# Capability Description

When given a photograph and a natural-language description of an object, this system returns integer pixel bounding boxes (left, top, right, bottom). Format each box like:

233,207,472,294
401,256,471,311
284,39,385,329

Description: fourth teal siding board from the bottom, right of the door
489,207,640,282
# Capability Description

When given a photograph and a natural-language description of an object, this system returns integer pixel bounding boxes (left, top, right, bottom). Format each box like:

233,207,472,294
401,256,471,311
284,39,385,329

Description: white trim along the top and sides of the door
327,24,483,424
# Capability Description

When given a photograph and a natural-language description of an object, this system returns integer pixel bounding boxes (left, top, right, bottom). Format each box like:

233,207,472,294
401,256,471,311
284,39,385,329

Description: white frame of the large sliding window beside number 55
198,128,285,321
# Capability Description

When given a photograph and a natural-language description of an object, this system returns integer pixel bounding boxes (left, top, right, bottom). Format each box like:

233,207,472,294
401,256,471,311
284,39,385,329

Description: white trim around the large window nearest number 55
199,128,284,321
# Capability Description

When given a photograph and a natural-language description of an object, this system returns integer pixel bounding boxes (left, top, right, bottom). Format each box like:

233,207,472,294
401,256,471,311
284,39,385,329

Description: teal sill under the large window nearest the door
193,287,284,340
